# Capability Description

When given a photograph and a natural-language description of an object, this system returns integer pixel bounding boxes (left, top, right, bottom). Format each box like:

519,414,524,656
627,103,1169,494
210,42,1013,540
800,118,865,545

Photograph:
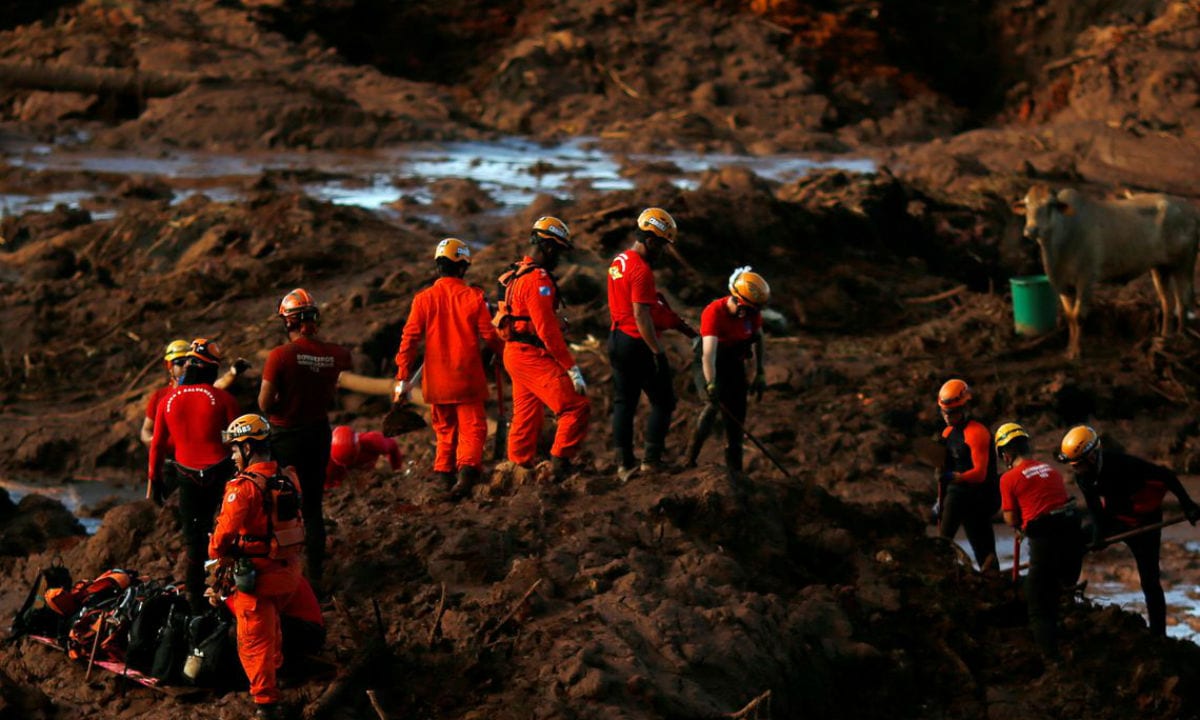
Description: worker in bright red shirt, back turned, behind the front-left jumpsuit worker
146,338,239,611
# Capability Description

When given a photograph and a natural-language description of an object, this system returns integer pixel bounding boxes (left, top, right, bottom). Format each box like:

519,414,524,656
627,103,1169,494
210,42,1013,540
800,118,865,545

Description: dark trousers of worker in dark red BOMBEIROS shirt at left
271,422,332,586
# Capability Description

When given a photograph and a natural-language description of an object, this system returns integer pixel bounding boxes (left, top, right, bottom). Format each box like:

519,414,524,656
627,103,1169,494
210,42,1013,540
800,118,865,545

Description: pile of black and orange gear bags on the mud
8,565,245,688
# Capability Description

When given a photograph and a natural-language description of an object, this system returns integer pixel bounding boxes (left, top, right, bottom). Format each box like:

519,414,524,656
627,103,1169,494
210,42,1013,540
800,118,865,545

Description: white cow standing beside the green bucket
1014,185,1200,360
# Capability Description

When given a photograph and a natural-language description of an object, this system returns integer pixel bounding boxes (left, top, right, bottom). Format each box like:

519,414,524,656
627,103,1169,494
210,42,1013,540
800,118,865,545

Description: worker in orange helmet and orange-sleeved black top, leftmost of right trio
934,378,1000,571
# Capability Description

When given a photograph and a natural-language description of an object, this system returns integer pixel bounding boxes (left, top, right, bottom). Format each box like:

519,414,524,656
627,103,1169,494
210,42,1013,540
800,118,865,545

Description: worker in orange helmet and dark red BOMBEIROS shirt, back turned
258,288,350,593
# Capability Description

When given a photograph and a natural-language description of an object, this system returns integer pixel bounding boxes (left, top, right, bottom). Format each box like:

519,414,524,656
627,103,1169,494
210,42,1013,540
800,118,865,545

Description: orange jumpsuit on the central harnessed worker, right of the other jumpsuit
504,257,592,466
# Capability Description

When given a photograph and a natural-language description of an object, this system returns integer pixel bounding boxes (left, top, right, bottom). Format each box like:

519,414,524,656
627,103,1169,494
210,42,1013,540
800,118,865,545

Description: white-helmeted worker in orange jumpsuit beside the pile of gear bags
209,414,301,719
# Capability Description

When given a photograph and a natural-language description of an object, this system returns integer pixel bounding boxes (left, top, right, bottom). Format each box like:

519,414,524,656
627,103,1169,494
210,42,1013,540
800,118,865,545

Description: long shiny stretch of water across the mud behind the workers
0,138,876,222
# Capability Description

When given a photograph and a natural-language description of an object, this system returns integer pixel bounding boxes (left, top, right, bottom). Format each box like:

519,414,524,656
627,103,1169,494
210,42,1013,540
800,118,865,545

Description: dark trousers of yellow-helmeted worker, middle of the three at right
1025,512,1084,659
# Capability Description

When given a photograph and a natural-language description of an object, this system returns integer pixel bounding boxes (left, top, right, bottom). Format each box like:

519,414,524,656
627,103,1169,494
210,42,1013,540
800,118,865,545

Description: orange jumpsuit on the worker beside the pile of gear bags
209,462,300,704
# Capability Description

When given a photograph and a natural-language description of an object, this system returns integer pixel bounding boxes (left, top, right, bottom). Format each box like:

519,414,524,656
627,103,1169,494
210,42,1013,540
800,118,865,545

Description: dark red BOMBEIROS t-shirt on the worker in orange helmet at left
263,335,350,427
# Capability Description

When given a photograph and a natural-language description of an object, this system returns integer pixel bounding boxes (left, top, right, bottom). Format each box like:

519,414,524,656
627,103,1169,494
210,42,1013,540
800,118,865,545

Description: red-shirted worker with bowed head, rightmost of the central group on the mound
686,266,770,480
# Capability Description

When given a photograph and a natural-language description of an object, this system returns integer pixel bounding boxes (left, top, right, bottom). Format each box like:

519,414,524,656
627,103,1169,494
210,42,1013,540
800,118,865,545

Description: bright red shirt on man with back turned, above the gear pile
150,384,239,481
